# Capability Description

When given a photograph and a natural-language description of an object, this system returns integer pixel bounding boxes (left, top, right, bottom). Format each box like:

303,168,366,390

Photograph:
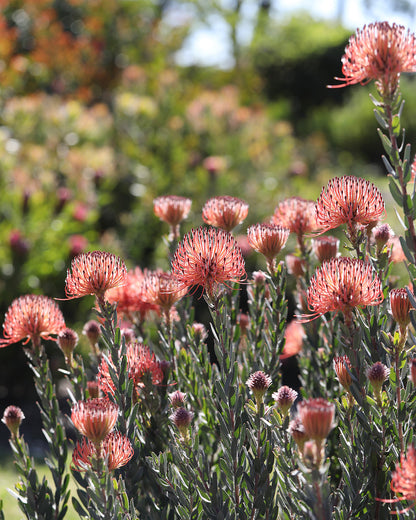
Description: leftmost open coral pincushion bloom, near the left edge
0,294,65,347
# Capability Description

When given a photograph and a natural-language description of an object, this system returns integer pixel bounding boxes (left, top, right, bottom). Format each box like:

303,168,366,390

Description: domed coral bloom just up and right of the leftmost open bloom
65,251,127,299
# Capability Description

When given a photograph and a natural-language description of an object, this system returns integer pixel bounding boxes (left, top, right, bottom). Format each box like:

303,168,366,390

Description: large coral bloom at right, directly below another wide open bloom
302,257,383,325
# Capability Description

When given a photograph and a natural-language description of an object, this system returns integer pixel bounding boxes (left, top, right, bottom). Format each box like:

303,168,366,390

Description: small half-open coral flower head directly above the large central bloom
202,195,248,231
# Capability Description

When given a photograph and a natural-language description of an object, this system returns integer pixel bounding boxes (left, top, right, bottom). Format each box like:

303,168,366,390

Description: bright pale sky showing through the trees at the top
177,0,415,68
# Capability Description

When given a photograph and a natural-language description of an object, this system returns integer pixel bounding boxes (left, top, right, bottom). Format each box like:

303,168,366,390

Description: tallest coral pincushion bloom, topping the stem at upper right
331,22,416,96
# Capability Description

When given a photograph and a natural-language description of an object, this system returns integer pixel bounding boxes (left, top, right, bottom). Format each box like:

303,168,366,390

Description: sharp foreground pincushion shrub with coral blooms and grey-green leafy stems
0,22,416,520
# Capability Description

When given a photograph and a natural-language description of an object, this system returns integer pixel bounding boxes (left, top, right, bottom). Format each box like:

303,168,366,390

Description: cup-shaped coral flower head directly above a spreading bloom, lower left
71,397,119,445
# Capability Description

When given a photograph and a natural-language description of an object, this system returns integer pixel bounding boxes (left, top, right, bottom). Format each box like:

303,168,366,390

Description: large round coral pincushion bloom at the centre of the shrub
172,227,246,298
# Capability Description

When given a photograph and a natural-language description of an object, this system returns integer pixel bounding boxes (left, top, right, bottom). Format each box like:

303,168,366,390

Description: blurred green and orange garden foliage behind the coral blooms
0,0,416,446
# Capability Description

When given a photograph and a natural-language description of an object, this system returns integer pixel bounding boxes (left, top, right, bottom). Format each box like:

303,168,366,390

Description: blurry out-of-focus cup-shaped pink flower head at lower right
298,397,335,442
